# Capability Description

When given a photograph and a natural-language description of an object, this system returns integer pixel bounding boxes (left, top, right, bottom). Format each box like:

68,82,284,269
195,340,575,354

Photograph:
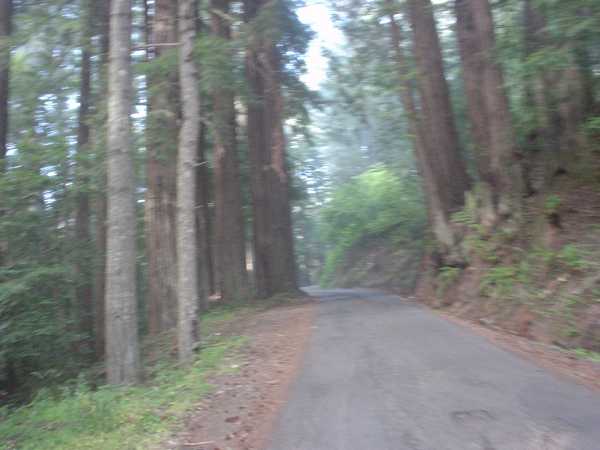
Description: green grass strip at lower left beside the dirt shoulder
0,309,245,450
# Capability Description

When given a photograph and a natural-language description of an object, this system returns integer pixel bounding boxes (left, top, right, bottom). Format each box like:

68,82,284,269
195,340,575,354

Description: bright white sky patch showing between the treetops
297,0,344,90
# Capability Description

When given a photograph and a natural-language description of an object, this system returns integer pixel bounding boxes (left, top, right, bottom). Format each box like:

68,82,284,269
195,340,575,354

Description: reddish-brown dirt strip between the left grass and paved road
161,299,315,450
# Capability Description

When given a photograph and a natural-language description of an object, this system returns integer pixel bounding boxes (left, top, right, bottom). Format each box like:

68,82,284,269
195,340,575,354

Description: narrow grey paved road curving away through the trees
270,290,600,450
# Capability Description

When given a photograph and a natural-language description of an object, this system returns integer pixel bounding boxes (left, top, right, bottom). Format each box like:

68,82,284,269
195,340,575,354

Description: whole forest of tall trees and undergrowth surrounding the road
0,0,600,449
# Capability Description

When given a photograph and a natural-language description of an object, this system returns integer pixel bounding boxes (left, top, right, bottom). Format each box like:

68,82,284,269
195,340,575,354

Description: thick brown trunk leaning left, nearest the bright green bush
408,0,470,253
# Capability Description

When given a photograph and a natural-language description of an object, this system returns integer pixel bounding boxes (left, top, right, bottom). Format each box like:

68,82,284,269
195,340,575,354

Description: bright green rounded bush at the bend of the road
321,165,425,283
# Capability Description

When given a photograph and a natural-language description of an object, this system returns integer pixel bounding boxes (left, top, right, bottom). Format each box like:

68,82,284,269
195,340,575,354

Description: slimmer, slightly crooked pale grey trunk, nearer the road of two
177,0,200,362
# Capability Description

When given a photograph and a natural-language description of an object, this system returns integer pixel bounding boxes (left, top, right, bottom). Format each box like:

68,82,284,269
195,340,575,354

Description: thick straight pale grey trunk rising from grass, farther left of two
106,0,140,384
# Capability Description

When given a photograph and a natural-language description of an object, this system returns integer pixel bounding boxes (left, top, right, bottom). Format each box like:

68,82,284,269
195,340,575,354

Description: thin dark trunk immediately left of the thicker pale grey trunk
94,0,111,360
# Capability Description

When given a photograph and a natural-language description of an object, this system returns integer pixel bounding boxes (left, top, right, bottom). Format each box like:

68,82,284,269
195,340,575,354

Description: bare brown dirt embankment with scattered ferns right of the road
417,165,600,358
